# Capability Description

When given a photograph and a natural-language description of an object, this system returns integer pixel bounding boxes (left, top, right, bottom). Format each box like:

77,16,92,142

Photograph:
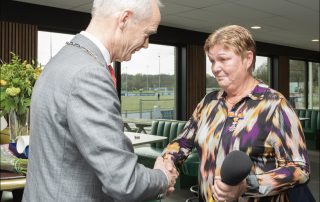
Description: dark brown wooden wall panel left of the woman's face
186,45,206,117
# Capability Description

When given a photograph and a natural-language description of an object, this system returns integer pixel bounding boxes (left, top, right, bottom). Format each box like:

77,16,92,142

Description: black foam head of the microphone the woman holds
221,151,253,186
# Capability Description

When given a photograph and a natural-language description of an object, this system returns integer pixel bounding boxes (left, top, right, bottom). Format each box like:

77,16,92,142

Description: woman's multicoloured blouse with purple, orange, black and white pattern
163,83,310,201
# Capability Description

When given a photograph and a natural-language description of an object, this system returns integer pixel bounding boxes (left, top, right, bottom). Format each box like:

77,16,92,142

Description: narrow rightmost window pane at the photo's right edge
308,62,320,109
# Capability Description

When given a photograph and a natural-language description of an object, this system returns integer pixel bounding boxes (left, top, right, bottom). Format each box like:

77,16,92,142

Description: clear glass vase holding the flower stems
9,109,29,142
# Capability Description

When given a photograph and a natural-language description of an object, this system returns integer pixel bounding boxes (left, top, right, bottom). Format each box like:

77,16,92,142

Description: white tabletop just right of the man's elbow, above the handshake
124,132,167,146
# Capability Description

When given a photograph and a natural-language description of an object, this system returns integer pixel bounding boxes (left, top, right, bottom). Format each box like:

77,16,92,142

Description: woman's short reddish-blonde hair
204,25,256,71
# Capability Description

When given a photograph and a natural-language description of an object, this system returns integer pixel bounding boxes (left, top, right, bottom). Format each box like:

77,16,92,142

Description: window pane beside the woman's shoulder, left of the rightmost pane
289,60,306,109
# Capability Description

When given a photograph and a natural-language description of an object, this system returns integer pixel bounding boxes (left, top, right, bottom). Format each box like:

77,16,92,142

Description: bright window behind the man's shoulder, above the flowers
38,31,74,65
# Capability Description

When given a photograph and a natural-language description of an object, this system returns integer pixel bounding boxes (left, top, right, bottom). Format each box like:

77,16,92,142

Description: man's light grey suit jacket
23,34,167,202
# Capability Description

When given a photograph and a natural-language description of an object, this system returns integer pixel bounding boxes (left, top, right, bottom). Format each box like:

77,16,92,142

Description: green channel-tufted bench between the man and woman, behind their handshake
134,119,186,168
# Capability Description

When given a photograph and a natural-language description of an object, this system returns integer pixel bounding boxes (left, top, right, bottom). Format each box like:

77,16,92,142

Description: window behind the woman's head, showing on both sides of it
206,56,271,93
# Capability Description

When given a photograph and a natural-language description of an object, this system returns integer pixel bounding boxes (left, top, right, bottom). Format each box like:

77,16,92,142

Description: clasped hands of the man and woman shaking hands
153,156,179,194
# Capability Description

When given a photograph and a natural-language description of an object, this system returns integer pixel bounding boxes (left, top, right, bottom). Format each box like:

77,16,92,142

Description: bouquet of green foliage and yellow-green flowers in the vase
0,53,42,115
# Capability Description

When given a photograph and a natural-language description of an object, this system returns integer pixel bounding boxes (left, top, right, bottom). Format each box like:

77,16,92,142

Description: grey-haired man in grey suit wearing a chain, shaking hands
23,0,178,202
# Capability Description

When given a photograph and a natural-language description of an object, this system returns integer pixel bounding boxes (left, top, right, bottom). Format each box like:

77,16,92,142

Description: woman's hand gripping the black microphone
211,176,247,202
